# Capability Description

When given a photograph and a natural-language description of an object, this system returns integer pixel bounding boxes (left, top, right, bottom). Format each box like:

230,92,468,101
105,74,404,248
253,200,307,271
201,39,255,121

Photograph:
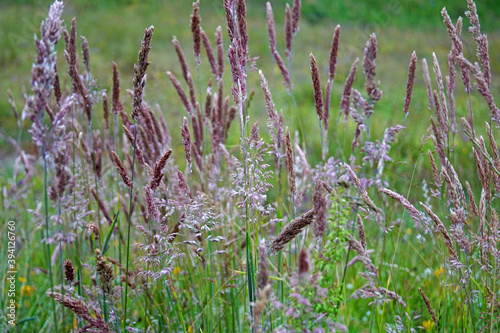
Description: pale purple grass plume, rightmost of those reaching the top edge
465,0,491,87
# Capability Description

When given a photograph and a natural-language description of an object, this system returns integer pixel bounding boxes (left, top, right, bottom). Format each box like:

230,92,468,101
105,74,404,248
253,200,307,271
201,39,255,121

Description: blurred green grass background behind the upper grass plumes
0,0,500,161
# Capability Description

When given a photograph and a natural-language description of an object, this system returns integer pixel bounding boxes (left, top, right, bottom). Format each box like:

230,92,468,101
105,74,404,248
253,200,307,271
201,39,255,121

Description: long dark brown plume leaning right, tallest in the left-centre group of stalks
131,26,154,121
